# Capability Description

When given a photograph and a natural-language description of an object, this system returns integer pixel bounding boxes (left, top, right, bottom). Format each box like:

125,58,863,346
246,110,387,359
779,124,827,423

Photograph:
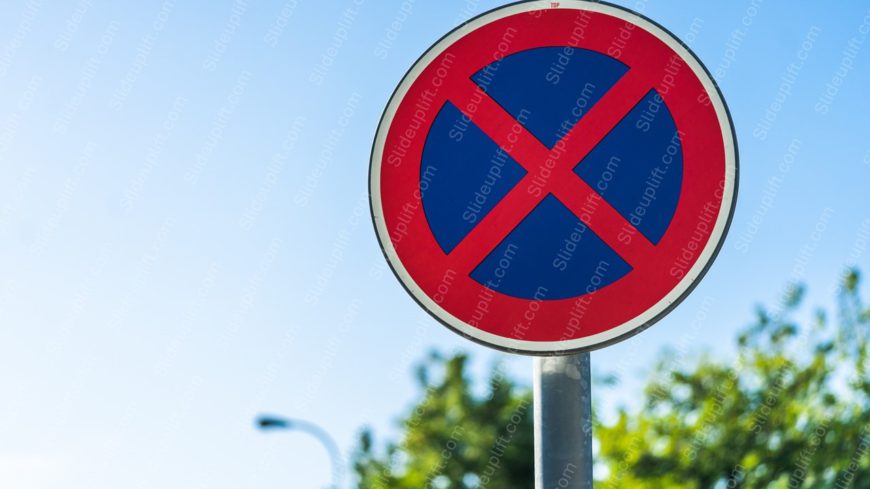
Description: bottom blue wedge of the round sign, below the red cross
471,195,631,300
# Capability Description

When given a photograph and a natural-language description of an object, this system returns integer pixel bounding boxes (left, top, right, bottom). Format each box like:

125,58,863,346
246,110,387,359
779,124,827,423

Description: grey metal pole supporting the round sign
534,353,592,489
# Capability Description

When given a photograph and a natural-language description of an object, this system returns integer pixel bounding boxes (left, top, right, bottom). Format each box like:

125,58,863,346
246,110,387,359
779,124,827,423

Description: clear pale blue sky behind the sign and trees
0,0,870,489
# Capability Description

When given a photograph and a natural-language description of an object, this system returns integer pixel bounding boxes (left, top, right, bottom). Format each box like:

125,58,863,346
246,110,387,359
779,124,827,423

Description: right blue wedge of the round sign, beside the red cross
574,90,683,244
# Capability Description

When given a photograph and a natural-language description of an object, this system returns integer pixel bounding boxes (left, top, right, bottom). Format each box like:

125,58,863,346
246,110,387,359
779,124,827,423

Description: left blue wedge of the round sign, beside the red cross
420,102,526,253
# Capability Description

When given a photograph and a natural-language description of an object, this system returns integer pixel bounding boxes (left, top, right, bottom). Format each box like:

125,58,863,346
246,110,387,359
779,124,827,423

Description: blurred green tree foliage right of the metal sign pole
596,272,870,489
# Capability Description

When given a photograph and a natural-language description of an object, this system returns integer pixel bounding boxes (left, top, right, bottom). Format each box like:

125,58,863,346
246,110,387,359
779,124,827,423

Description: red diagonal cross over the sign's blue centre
449,69,655,273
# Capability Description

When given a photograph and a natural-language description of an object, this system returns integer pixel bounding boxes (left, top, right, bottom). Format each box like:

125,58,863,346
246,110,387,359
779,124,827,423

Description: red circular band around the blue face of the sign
380,9,727,341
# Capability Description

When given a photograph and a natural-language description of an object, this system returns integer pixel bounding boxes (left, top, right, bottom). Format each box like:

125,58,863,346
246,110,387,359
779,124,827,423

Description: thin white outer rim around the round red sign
369,0,738,355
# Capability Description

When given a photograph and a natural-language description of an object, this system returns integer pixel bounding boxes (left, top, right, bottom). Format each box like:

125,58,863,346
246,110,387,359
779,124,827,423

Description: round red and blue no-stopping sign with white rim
370,1,737,355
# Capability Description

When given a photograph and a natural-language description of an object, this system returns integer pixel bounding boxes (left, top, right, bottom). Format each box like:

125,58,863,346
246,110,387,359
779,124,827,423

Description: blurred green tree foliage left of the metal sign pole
354,348,534,489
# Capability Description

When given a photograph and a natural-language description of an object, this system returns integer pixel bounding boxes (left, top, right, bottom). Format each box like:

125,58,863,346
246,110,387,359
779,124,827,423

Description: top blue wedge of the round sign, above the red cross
471,46,628,148
